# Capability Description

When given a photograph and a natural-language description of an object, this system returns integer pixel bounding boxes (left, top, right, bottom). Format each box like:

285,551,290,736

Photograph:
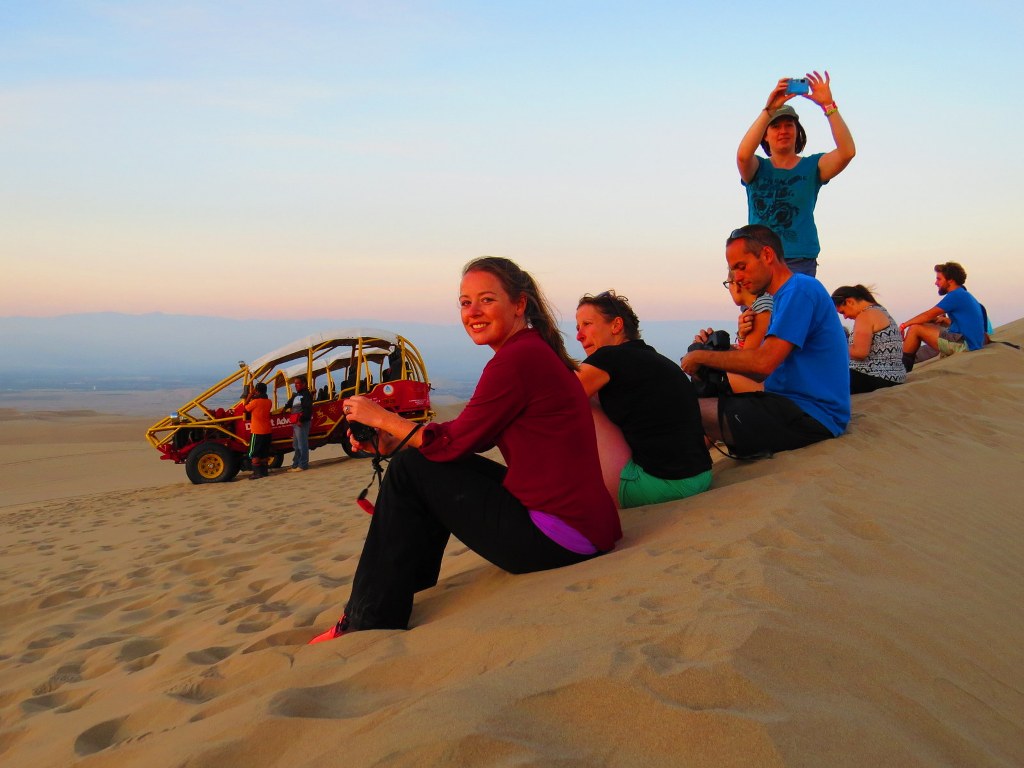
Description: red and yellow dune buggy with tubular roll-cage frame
145,329,433,483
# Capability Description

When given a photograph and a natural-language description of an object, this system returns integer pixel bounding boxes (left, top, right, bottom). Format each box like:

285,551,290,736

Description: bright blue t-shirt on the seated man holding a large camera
765,274,850,436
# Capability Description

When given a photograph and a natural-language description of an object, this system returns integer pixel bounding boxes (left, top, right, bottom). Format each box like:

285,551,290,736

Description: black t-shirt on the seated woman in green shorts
584,339,711,480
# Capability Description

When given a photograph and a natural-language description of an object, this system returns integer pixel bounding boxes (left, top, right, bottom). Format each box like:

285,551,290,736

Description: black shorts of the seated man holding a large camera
718,392,835,457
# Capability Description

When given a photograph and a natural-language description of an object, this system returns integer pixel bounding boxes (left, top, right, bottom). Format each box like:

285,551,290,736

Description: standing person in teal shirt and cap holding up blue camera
736,72,857,278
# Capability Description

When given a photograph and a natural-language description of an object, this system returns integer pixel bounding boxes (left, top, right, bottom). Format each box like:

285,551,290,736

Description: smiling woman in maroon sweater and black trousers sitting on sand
311,257,622,642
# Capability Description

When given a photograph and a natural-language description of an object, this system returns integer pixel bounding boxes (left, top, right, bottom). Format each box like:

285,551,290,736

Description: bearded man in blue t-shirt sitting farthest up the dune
899,261,985,373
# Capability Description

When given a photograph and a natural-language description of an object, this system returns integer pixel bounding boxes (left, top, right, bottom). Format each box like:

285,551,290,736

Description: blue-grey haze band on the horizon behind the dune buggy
0,312,720,398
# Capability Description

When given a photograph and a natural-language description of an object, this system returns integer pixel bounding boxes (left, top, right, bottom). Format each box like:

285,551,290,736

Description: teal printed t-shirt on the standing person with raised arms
742,153,835,262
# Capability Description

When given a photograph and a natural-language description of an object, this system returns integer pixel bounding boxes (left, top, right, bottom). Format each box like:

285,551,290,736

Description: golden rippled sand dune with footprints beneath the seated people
0,321,1024,768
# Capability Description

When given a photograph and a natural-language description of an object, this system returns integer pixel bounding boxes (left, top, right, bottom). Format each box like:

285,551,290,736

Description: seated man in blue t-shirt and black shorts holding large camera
681,224,850,456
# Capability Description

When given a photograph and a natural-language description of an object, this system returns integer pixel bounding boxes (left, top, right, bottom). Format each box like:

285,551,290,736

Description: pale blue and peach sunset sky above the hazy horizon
0,0,1024,332
